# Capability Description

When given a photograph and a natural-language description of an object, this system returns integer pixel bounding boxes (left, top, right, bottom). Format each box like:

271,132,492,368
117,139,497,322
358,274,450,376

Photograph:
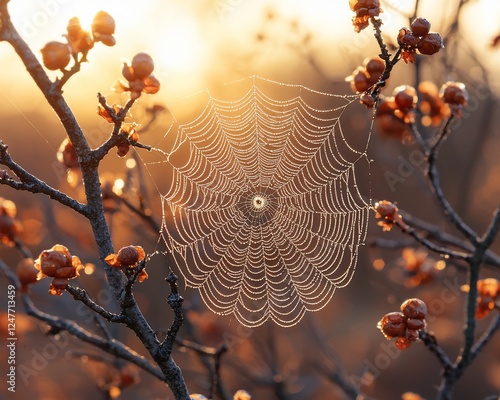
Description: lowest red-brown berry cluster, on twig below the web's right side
377,299,427,350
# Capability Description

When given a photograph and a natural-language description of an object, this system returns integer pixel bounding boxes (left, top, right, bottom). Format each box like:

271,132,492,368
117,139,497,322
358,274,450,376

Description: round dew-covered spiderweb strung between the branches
151,77,370,327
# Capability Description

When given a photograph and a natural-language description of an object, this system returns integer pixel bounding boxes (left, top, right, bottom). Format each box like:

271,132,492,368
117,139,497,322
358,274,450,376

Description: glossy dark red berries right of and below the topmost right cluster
398,18,444,63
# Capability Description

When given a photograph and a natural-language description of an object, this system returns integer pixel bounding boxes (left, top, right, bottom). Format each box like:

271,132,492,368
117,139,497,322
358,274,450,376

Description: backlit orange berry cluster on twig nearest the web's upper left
113,53,160,100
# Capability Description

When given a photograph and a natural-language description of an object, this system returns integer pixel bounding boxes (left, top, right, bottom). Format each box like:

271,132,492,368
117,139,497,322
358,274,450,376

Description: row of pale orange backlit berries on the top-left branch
40,11,116,71
